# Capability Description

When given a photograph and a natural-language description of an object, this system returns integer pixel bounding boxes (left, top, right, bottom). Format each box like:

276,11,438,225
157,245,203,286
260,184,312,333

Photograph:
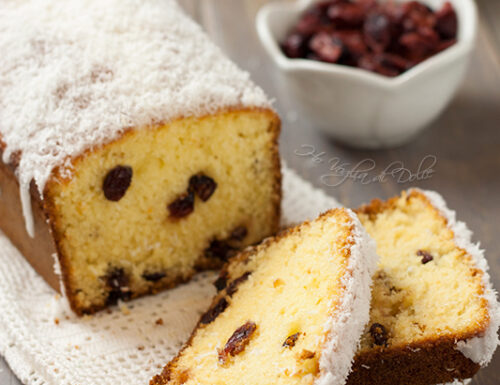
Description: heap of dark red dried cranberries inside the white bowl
282,0,457,76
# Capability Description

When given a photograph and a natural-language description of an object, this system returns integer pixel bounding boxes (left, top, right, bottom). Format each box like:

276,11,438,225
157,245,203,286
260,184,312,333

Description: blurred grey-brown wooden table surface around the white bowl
0,0,500,385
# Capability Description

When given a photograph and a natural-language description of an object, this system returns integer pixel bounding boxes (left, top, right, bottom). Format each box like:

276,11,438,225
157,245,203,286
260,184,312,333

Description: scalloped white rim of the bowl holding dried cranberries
256,0,477,89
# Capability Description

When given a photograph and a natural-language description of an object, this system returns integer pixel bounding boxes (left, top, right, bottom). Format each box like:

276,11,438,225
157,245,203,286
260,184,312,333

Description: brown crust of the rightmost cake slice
347,190,489,385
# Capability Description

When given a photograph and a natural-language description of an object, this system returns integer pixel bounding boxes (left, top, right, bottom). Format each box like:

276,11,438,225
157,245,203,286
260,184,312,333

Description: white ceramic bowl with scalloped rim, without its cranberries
257,0,477,148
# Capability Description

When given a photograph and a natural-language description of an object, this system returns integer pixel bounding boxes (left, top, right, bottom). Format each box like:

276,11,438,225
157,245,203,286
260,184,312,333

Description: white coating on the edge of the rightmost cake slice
416,189,500,366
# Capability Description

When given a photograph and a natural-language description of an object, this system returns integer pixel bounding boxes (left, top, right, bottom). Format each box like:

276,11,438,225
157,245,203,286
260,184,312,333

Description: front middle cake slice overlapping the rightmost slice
150,209,378,385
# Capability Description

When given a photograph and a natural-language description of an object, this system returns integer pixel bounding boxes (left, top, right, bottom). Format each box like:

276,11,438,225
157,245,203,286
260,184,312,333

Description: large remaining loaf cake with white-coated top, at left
0,0,281,314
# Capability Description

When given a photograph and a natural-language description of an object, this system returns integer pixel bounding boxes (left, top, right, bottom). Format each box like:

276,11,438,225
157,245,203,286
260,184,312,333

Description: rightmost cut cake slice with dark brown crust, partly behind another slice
348,189,500,385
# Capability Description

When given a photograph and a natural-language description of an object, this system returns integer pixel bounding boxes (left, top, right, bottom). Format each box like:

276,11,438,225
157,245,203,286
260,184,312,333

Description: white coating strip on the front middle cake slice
314,209,379,385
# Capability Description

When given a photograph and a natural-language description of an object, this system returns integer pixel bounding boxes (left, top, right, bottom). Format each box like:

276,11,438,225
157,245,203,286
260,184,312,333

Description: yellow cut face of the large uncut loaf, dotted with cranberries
45,110,279,312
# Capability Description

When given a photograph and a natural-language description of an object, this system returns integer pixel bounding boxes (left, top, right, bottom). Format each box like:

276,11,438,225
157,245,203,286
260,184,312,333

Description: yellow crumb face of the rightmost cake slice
358,191,488,354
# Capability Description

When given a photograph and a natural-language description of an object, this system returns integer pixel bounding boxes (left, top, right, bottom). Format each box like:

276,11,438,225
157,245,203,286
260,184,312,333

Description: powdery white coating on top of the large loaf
0,0,270,235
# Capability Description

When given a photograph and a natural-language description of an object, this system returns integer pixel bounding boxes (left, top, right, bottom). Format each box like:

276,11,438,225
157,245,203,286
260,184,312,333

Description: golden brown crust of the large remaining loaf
0,108,281,316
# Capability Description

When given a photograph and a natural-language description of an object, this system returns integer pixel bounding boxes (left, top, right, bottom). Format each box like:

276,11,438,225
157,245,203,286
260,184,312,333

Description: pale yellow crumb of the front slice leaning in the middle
159,211,351,385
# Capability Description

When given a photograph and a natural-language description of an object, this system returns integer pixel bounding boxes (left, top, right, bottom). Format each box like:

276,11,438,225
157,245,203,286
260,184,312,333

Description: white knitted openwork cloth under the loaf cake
0,167,338,385
